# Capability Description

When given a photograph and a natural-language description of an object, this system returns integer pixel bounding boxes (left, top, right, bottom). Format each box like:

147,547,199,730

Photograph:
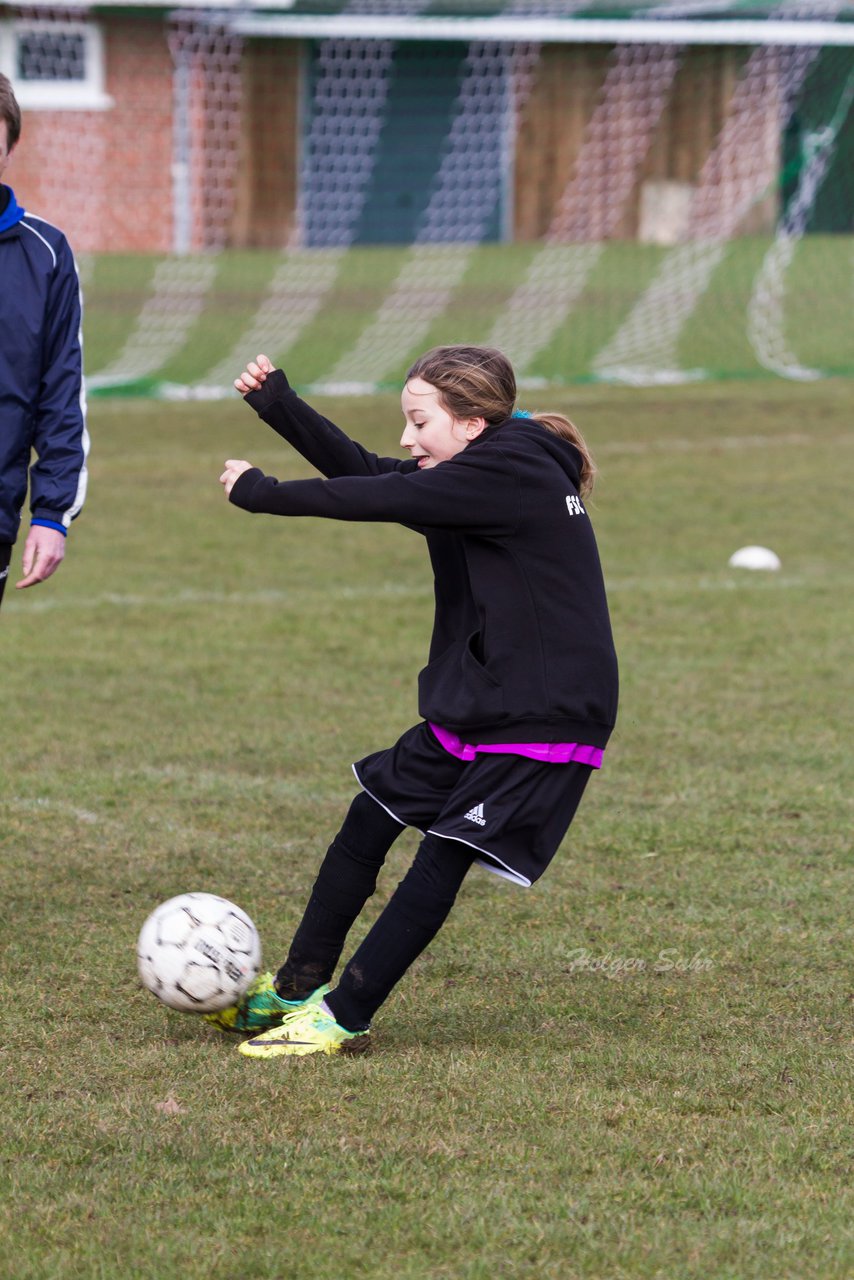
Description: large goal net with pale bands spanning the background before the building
8,0,854,396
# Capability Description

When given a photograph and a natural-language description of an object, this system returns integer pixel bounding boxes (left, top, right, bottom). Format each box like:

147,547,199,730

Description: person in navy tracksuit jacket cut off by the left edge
0,76,88,600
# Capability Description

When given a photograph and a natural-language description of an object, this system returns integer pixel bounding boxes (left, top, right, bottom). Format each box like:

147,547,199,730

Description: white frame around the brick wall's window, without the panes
0,18,113,111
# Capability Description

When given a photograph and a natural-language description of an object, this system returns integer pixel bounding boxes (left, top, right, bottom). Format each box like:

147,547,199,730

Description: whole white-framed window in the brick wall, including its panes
0,20,111,111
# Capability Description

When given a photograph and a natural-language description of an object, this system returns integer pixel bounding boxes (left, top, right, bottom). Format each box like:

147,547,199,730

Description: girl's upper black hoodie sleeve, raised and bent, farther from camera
246,369,416,477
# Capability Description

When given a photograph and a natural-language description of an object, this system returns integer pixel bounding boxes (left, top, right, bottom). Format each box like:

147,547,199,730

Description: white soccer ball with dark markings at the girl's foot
137,893,261,1014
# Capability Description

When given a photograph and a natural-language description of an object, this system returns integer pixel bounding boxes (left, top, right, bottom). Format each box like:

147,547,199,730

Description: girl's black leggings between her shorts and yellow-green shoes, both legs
275,792,475,1030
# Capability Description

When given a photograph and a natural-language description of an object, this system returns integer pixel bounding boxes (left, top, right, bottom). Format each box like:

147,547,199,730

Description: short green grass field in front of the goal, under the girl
0,380,854,1280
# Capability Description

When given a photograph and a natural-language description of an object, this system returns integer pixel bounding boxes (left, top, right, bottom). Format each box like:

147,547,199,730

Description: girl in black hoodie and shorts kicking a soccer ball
209,347,617,1057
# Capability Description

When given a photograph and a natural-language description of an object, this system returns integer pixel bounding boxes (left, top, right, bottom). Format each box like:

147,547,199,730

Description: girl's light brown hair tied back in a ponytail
406,346,597,497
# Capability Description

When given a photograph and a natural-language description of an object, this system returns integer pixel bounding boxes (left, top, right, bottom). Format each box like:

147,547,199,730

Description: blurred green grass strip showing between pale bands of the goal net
86,236,854,385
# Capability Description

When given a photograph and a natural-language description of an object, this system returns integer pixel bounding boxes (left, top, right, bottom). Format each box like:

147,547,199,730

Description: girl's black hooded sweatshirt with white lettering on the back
230,370,617,746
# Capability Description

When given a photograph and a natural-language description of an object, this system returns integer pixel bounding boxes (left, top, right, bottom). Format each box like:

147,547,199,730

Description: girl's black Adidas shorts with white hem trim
353,723,593,887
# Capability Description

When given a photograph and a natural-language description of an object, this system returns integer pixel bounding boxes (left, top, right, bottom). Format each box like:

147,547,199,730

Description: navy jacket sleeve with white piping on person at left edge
29,237,88,527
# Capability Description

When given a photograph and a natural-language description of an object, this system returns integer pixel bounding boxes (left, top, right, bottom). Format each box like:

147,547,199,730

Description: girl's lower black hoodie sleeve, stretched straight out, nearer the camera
230,448,521,536
